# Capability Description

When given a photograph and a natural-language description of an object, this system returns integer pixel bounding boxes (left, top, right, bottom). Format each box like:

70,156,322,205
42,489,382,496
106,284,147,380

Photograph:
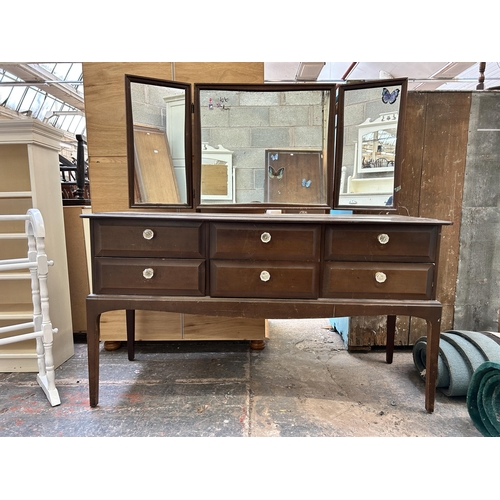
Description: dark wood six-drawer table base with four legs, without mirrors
82,212,449,412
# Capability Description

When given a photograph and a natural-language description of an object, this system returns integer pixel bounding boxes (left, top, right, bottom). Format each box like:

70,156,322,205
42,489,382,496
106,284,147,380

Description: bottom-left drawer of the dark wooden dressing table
93,257,205,295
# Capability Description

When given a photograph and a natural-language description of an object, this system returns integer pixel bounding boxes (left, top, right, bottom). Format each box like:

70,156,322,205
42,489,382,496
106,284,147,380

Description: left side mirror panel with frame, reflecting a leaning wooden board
125,75,192,208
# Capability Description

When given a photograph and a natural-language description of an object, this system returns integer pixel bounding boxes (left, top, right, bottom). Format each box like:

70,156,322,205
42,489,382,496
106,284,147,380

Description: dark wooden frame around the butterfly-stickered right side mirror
333,78,408,213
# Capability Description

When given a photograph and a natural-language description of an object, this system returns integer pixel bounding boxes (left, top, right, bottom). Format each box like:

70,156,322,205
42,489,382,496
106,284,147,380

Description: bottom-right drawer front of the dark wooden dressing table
322,262,434,300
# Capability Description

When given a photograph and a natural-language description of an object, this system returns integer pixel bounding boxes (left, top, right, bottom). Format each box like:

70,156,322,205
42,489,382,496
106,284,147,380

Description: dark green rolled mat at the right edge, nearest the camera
467,361,500,437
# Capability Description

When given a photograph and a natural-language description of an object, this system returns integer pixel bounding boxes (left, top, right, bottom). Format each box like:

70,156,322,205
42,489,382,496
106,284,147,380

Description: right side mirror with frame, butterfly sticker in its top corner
335,79,407,211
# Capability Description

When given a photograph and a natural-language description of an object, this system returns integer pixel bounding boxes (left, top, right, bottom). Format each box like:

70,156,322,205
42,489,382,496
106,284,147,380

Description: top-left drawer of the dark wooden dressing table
93,219,205,259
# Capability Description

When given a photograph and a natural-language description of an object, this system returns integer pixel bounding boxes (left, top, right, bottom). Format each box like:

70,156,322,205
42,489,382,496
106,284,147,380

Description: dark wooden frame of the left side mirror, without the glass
125,74,193,209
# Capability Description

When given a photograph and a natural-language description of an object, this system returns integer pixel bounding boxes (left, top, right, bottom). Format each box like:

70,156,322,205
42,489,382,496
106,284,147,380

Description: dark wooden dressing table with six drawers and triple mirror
82,75,449,412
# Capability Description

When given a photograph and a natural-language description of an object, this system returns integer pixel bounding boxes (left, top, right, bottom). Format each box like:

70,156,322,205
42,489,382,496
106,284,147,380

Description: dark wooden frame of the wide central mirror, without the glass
193,83,337,211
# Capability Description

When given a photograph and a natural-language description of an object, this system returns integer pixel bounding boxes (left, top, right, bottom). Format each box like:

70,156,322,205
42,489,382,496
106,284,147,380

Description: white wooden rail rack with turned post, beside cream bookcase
0,208,61,406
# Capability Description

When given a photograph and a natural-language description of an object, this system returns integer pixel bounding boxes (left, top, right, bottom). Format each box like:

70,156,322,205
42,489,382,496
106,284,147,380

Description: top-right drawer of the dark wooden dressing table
324,225,439,262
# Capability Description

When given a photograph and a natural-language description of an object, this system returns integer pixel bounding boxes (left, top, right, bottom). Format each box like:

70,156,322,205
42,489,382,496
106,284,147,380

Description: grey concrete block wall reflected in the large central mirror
200,90,324,203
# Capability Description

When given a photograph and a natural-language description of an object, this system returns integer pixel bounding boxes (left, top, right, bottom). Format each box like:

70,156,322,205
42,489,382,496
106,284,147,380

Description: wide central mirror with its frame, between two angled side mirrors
194,84,335,209
